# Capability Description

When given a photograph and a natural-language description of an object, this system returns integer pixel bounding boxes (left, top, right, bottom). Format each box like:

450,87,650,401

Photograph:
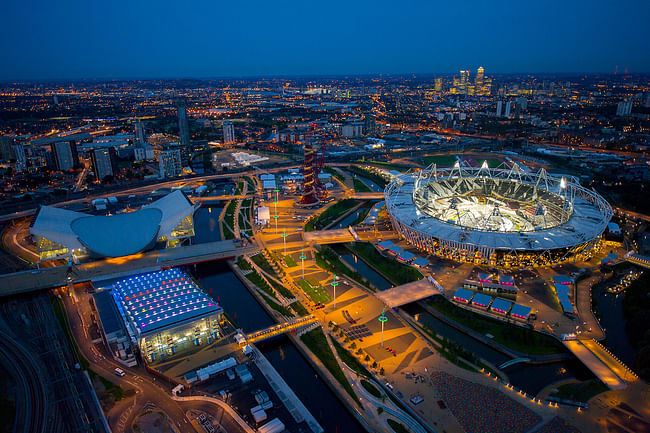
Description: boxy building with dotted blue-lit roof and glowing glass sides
111,269,223,362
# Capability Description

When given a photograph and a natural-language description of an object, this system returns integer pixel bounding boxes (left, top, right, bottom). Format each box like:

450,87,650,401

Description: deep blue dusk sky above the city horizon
0,0,650,80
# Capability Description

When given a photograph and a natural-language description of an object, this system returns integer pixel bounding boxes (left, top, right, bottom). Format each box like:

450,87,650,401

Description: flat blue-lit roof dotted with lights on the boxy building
112,269,221,336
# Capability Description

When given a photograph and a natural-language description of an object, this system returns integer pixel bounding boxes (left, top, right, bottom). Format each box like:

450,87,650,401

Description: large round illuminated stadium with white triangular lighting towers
384,161,612,267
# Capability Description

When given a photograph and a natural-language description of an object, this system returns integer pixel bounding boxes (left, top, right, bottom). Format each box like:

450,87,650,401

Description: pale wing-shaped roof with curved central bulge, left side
30,191,194,257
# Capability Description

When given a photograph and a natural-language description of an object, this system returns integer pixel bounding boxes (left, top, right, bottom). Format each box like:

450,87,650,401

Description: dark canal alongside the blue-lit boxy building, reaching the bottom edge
195,261,363,433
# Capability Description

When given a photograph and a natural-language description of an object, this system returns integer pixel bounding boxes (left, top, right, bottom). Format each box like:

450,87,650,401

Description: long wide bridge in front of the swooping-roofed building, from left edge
0,240,258,297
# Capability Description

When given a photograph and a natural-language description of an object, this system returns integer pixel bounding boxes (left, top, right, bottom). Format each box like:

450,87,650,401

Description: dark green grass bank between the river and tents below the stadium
428,295,566,355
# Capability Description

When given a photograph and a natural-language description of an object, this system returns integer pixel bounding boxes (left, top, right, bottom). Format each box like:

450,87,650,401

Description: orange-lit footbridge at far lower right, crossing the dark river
562,338,638,389
